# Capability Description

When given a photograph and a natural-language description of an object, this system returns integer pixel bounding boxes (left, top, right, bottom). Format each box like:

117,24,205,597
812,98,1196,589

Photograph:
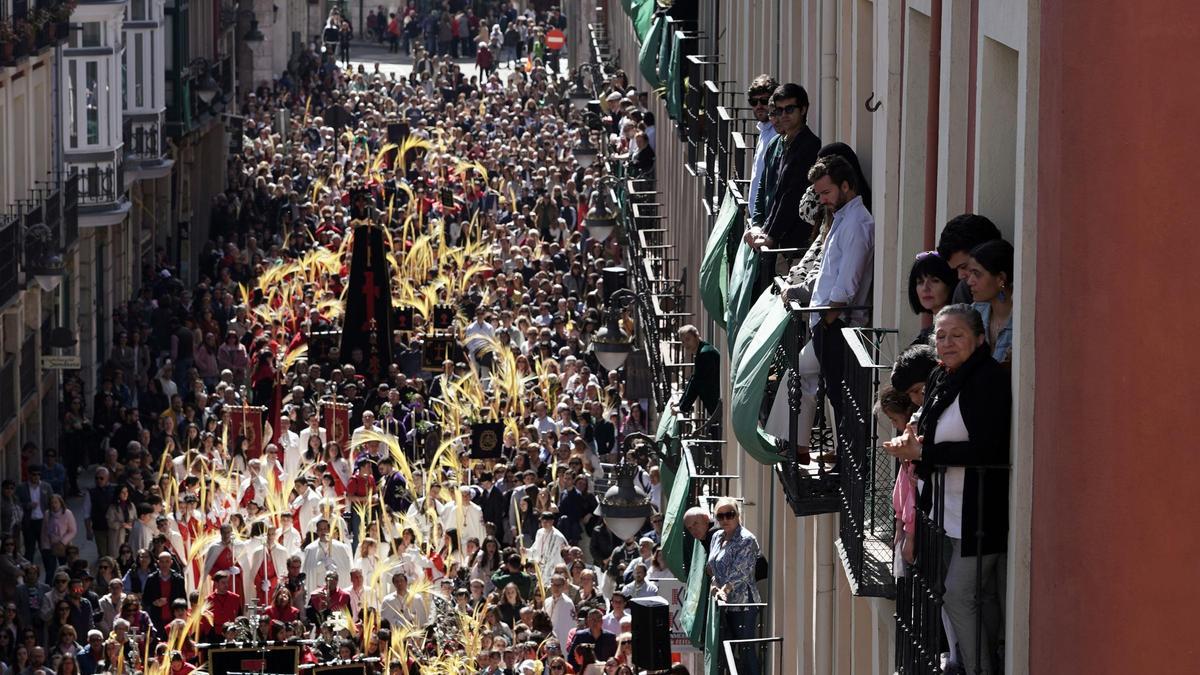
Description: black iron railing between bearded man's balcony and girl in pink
836,328,899,598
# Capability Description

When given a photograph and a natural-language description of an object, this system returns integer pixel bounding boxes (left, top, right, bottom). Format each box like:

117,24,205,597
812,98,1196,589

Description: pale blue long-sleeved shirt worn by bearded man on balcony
810,192,875,325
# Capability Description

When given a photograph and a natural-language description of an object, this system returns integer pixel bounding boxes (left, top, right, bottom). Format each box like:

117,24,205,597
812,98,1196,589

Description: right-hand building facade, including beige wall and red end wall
600,0,1198,675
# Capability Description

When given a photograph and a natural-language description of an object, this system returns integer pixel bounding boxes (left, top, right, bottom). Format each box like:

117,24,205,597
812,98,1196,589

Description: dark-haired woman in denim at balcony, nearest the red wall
967,239,1013,364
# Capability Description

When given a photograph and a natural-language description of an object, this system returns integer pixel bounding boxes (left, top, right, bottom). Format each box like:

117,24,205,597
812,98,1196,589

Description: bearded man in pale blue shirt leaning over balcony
796,155,875,464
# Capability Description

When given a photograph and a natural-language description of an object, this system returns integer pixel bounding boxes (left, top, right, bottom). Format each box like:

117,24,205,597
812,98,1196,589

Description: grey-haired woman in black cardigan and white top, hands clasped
883,304,1012,674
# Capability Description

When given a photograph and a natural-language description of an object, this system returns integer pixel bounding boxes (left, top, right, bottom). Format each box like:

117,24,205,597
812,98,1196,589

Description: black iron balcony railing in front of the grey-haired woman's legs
895,465,1009,675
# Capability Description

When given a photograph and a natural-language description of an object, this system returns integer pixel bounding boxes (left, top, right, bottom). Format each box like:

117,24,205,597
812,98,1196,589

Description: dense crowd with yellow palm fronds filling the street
0,2,679,675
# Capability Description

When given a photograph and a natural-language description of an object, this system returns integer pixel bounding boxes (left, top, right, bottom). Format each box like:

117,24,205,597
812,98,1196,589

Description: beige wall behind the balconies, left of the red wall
604,0,1040,675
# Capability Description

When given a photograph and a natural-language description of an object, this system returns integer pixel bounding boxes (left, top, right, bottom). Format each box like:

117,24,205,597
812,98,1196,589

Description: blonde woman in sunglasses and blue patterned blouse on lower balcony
708,497,760,673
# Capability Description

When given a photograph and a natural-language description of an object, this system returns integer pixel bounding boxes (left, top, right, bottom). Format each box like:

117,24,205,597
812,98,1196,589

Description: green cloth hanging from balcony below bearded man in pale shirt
730,293,790,465
